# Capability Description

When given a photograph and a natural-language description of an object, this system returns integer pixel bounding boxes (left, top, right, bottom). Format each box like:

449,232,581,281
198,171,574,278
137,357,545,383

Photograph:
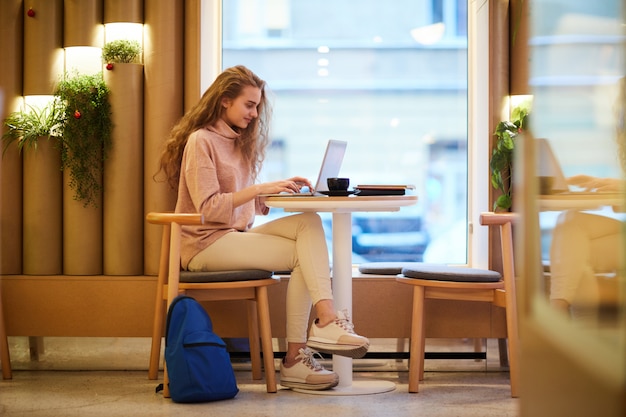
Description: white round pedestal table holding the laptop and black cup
265,195,417,395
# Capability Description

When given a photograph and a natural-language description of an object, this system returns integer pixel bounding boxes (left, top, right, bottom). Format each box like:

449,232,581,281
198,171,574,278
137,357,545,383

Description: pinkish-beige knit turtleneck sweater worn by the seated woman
176,120,269,269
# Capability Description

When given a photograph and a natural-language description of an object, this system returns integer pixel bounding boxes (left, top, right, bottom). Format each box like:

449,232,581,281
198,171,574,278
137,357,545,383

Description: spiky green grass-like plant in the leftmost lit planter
2,99,64,152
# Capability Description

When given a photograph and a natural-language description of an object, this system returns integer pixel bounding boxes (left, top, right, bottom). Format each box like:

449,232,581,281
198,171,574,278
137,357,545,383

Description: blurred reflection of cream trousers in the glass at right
550,211,623,306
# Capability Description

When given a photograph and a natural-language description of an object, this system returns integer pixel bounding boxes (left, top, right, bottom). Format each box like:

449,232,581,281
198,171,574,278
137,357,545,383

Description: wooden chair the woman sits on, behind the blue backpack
147,213,280,397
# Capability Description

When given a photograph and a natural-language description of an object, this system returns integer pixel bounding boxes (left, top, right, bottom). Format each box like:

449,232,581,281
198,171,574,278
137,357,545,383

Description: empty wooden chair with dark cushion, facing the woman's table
396,213,519,397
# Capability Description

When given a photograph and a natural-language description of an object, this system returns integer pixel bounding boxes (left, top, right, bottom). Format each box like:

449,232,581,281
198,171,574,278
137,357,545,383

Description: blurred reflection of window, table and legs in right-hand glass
530,0,626,326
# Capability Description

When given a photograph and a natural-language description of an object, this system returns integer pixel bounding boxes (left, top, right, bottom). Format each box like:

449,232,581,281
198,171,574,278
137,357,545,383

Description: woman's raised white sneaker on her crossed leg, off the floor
306,310,370,359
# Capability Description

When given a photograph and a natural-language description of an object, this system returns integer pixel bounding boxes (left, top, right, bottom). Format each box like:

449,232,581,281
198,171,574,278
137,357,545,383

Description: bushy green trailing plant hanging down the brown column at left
55,74,113,207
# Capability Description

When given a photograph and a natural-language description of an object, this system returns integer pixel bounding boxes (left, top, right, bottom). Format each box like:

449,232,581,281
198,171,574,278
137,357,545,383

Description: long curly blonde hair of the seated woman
157,65,271,190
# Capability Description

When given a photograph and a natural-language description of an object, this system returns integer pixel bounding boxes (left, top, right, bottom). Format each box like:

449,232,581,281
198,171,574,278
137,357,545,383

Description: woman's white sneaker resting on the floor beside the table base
280,348,339,390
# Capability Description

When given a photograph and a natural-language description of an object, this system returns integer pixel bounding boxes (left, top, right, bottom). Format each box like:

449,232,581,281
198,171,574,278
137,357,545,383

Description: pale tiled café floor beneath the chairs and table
0,338,519,417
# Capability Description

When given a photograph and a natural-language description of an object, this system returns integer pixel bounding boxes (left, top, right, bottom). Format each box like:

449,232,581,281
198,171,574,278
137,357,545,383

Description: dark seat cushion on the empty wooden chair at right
402,264,502,282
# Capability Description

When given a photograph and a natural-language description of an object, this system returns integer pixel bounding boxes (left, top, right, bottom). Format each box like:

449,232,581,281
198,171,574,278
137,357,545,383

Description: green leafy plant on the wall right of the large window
489,100,530,211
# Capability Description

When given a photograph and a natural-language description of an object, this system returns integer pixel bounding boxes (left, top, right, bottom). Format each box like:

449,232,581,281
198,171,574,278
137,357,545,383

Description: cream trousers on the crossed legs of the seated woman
189,213,333,343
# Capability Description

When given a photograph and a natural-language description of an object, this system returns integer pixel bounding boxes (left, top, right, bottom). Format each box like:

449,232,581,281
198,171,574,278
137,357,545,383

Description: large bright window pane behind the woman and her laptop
217,0,468,263
